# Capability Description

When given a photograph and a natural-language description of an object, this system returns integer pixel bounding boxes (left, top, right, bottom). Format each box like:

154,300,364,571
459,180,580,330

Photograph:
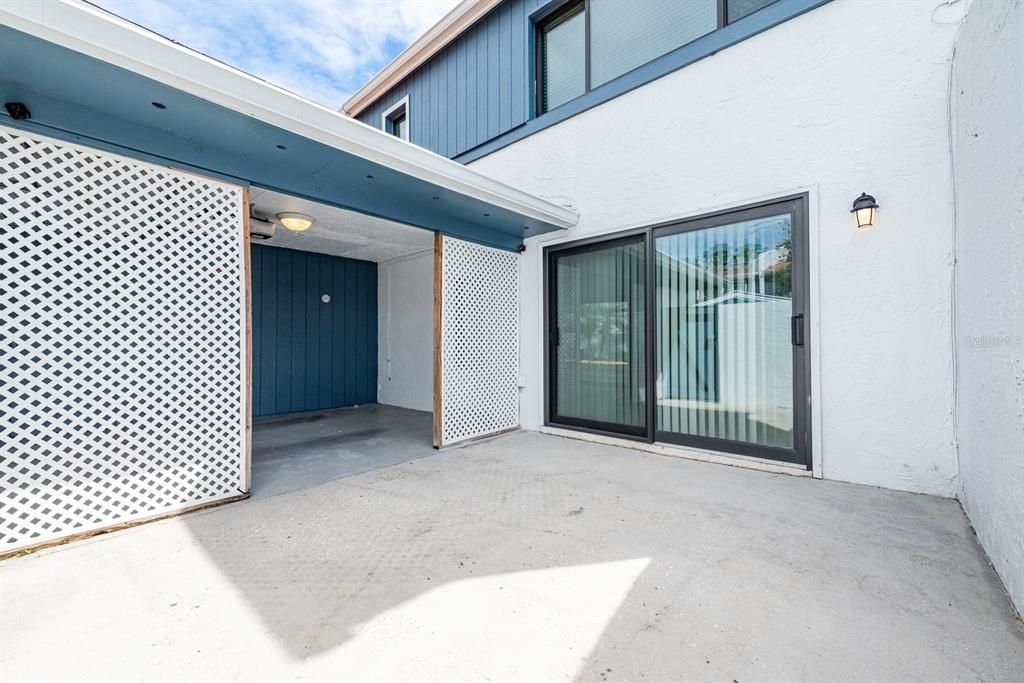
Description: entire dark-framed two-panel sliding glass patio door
548,198,809,464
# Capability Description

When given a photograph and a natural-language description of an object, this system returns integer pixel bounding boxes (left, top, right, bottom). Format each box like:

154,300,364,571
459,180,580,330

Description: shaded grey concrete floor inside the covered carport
252,403,434,498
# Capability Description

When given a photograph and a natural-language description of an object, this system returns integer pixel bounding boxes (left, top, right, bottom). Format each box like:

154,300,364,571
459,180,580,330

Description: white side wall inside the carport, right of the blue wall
377,249,434,411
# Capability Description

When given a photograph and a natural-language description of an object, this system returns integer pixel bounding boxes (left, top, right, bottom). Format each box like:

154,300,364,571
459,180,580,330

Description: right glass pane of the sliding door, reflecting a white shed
654,214,794,449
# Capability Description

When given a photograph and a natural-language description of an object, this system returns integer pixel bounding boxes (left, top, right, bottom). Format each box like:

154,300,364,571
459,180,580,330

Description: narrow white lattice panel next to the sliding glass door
441,238,519,445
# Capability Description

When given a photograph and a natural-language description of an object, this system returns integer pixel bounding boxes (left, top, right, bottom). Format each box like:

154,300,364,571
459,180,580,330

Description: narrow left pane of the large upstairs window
540,3,587,113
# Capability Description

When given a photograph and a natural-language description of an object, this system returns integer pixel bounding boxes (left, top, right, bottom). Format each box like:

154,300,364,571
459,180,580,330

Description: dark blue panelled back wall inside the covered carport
252,245,377,417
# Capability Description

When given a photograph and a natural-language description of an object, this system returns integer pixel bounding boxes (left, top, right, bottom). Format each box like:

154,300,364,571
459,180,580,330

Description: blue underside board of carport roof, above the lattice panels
0,26,554,250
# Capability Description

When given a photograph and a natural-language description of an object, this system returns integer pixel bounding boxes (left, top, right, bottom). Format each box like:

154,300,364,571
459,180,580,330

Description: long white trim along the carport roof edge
0,0,579,228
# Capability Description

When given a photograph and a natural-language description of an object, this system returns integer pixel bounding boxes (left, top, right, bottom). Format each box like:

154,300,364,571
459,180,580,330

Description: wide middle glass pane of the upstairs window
590,0,718,88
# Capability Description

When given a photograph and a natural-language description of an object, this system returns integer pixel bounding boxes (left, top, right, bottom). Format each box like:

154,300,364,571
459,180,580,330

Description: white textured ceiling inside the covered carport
256,188,434,262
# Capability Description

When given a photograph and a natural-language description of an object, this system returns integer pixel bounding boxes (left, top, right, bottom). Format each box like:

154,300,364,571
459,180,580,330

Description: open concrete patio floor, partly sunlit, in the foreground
0,432,1024,682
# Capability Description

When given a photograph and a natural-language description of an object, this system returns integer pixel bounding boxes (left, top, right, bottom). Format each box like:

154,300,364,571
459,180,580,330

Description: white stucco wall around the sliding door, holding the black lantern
473,0,957,496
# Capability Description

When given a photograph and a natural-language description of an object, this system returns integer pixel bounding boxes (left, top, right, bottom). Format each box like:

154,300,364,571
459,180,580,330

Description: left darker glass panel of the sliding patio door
550,241,647,433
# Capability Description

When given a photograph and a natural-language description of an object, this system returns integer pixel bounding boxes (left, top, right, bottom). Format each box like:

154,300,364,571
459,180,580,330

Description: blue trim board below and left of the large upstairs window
453,0,831,164
